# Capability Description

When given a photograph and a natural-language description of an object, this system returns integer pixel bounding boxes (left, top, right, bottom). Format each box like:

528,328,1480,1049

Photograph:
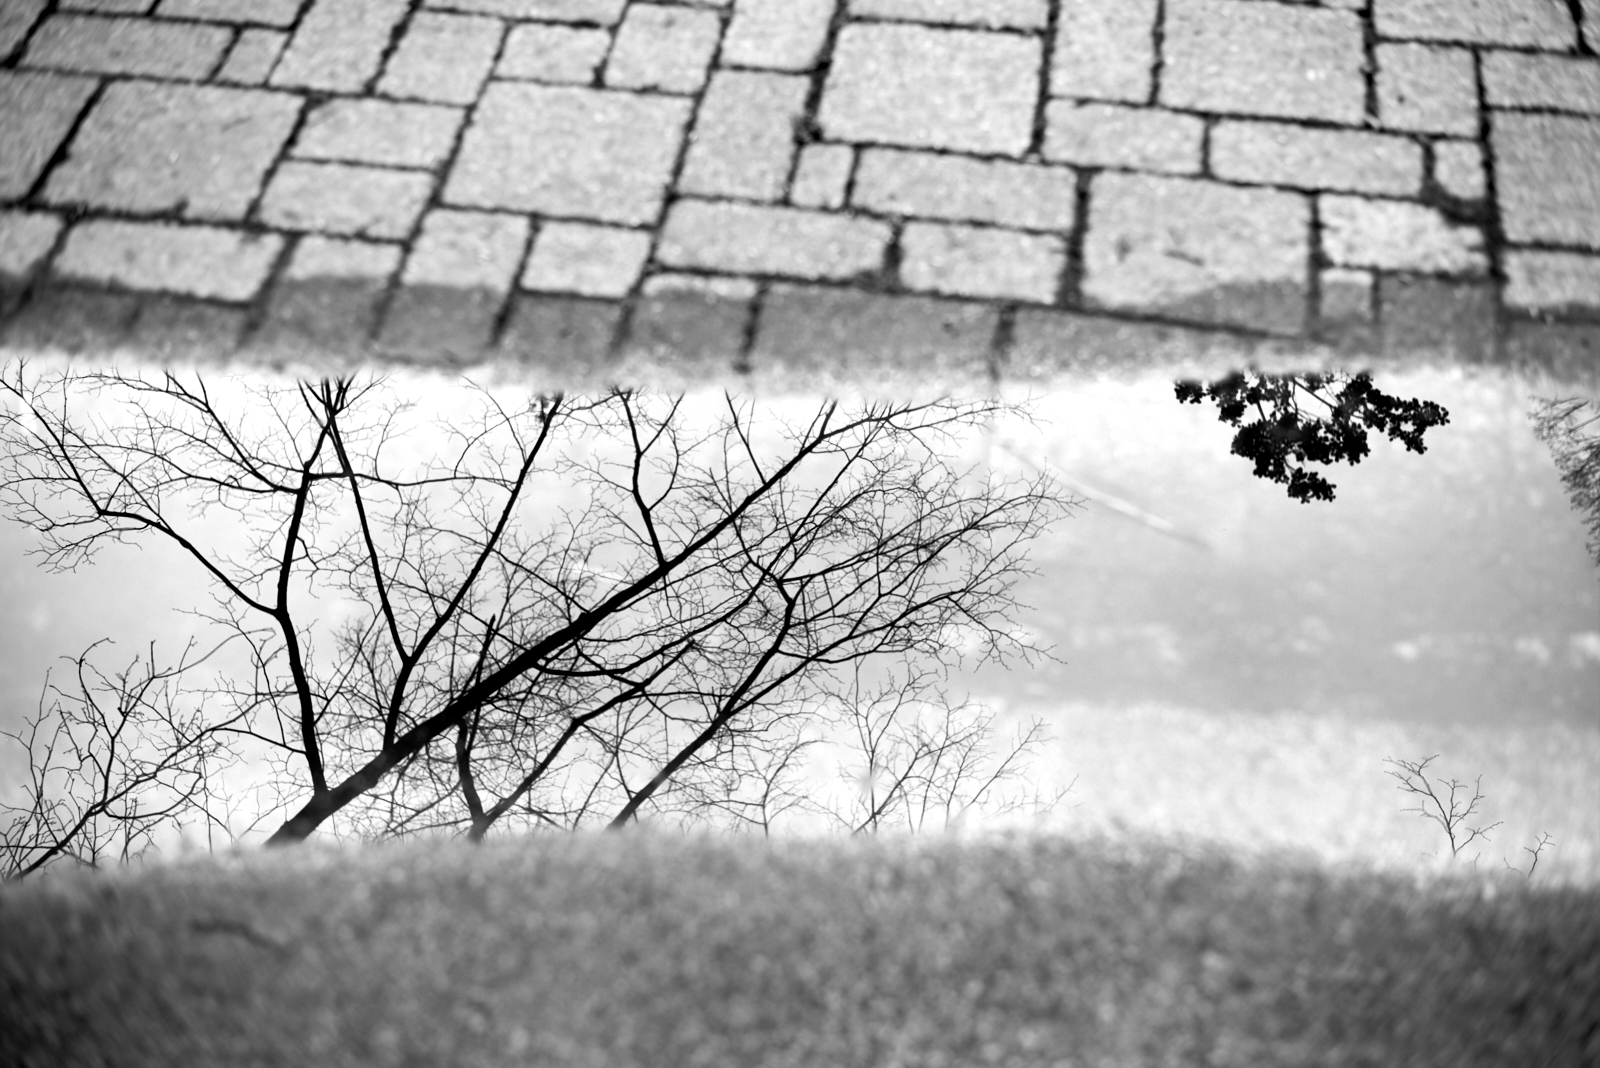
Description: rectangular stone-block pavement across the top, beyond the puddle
0,0,1600,387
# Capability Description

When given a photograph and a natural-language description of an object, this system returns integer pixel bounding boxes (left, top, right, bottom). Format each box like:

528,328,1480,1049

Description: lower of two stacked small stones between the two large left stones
259,161,434,238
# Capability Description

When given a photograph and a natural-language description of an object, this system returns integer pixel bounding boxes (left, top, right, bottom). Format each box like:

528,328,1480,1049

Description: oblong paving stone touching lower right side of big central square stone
1045,101,1205,174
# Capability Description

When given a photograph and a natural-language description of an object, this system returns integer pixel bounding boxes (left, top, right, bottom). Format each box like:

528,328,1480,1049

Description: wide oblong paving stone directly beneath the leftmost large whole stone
54,219,283,301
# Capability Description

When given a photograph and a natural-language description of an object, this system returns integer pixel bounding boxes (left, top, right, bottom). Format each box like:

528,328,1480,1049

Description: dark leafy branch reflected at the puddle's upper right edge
1176,368,1450,504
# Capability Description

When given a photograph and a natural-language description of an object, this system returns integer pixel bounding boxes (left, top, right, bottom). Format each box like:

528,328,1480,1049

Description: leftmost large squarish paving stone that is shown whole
45,82,301,219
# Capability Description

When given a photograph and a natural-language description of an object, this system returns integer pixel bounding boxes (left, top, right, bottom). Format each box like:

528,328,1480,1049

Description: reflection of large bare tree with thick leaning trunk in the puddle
0,365,1062,869
